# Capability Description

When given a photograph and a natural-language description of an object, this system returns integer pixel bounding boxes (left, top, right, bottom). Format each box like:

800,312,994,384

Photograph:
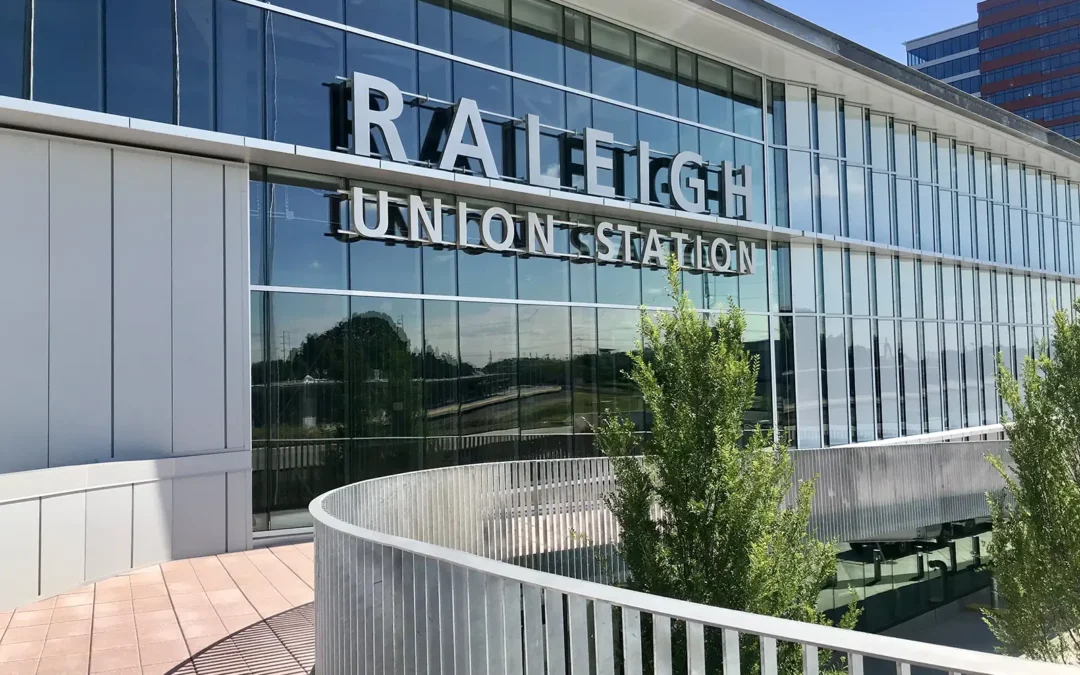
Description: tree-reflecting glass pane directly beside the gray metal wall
264,293,349,440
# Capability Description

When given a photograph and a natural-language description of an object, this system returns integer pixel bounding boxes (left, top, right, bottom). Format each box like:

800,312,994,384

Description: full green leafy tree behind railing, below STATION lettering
596,256,859,673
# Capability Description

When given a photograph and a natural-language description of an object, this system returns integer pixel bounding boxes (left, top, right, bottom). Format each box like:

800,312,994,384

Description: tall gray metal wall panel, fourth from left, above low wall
173,159,225,453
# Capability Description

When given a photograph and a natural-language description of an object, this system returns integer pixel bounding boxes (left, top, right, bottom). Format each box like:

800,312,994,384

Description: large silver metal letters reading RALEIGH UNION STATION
345,72,756,274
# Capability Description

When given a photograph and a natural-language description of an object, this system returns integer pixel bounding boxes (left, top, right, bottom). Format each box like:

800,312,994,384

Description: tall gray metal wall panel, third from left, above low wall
112,150,173,459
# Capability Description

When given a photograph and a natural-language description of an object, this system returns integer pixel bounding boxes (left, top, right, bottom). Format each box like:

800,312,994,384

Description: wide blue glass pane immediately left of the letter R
264,15,345,148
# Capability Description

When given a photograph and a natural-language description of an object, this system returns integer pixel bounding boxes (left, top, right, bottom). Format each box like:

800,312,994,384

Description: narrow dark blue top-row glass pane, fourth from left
176,0,215,129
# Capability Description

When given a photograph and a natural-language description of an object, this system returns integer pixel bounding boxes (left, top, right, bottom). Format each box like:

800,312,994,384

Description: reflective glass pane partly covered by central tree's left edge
596,309,645,431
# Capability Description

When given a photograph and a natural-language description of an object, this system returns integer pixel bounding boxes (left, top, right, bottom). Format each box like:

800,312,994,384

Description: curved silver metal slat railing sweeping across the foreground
311,444,1076,675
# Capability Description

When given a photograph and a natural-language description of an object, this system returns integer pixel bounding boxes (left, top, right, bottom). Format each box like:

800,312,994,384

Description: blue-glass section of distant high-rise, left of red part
904,22,982,96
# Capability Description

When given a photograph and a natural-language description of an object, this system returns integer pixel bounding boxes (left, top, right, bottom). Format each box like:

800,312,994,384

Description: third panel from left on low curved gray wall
85,485,133,579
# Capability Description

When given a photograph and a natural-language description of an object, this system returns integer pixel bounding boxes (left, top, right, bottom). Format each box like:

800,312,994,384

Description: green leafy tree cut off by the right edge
985,305,1080,662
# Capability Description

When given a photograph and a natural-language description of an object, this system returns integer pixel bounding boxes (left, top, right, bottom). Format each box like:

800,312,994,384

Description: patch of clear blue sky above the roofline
770,0,977,63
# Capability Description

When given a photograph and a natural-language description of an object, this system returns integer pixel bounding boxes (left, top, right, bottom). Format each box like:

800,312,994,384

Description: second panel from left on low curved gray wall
40,492,86,596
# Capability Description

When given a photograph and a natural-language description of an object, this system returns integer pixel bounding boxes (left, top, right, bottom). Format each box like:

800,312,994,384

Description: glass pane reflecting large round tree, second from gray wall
347,297,424,437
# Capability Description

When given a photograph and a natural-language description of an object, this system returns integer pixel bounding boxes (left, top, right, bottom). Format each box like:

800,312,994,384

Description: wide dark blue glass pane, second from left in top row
33,0,102,110
